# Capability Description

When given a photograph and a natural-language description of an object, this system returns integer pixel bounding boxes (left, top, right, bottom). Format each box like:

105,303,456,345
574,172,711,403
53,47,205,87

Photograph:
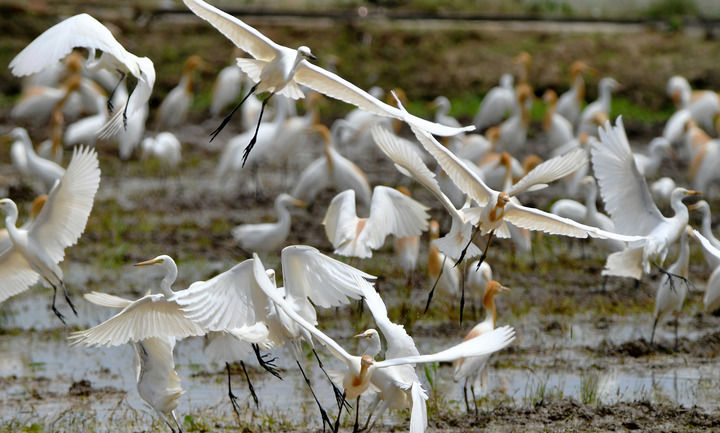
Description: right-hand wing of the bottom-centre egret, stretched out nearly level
375,326,515,368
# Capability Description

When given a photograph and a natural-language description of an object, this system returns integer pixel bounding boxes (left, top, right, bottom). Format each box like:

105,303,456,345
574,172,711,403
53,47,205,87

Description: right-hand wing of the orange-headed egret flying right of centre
503,202,644,242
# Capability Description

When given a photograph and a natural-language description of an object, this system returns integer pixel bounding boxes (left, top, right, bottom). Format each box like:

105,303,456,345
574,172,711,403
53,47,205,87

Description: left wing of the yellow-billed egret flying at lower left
68,294,205,346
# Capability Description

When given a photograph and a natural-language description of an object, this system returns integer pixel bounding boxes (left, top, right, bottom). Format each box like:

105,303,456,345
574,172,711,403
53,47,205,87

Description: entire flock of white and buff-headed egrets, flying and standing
0,0,720,433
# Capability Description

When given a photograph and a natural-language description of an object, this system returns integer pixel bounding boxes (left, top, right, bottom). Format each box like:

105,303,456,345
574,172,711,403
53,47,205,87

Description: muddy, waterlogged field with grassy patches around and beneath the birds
0,3,720,432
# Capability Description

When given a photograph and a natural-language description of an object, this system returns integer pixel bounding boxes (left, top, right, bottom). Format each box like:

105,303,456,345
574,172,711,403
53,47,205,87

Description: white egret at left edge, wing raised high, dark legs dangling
0,147,100,323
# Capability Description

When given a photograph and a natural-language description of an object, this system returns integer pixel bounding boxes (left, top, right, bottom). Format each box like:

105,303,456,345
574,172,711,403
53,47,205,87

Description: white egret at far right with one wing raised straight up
591,116,699,280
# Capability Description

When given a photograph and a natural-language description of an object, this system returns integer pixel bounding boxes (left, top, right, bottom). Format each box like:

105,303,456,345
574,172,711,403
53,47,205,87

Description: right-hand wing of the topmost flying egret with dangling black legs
292,61,475,136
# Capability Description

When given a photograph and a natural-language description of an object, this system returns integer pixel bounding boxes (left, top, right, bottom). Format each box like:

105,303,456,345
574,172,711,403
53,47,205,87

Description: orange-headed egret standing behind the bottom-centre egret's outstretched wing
453,280,510,416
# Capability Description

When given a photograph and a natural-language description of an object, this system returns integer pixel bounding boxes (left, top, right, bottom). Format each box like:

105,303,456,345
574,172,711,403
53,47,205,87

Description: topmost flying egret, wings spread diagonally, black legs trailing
183,0,475,165
